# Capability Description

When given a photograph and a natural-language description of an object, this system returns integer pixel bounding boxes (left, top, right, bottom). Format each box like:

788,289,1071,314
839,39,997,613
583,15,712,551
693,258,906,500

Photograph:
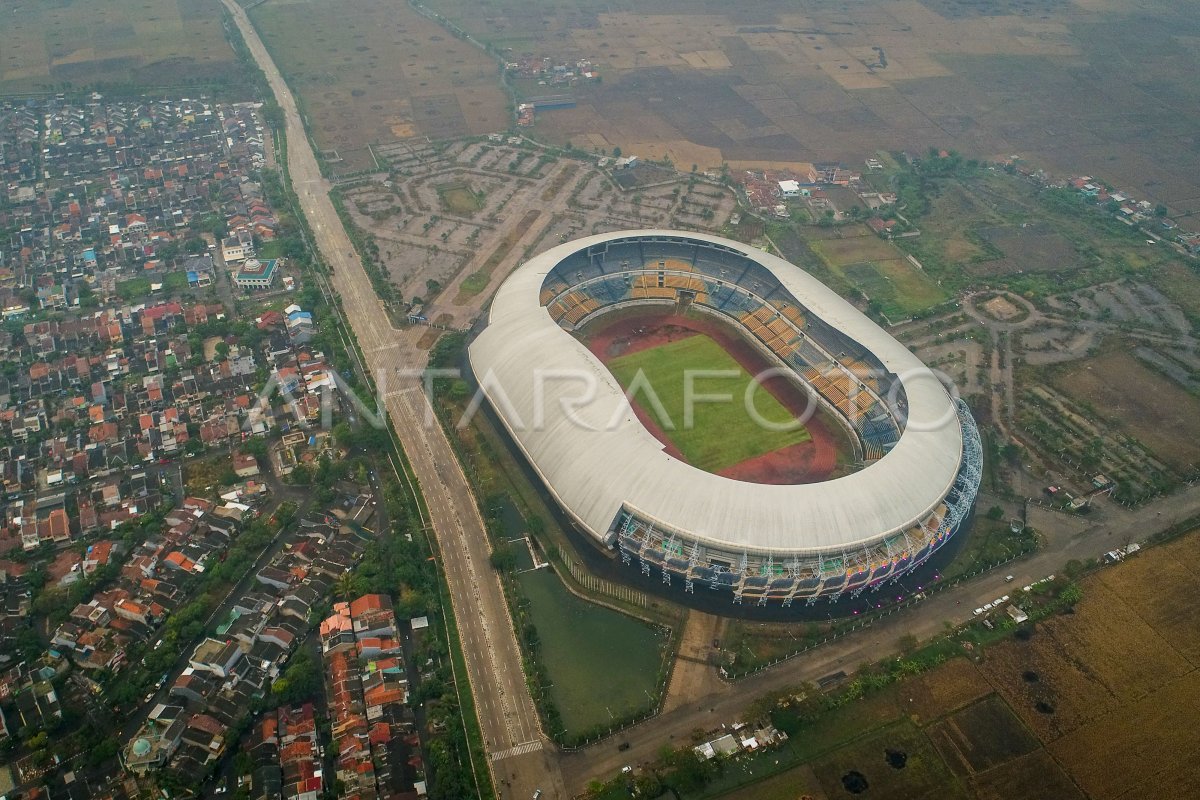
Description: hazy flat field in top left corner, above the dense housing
0,0,244,94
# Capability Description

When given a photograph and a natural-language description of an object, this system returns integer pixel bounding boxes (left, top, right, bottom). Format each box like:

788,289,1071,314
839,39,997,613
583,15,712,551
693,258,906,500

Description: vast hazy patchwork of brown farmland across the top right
427,0,1200,212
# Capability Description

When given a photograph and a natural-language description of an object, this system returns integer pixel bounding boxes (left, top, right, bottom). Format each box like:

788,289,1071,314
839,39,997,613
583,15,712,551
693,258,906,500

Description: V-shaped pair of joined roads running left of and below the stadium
223,6,1200,800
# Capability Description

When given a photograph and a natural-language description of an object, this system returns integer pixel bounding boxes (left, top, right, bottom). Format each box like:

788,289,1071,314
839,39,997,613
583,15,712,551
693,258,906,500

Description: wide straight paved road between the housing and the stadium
223,0,566,800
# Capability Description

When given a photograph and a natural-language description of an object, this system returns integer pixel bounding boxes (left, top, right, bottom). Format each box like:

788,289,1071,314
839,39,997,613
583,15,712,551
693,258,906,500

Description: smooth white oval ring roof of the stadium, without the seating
469,230,962,555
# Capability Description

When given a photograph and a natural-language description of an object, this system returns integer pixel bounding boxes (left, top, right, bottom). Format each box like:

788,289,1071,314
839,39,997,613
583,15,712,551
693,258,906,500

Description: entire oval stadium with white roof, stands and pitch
469,230,982,606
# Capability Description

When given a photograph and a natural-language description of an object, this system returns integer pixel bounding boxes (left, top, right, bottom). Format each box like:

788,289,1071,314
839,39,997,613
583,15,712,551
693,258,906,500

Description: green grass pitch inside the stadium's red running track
608,333,811,473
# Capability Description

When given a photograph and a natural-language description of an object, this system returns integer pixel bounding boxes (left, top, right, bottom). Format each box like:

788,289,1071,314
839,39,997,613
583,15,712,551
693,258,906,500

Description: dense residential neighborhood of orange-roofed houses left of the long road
0,95,444,798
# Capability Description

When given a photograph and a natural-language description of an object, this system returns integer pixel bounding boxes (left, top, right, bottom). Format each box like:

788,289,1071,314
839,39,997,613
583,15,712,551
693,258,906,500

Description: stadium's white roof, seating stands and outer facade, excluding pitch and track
469,230,982,606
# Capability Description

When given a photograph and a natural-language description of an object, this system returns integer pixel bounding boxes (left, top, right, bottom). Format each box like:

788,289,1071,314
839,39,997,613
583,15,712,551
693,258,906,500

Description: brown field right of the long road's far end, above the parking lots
250,0,511,174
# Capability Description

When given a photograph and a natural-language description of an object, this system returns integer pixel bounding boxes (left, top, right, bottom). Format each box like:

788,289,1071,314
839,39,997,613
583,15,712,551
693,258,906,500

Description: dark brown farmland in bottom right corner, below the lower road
705,531,1200,800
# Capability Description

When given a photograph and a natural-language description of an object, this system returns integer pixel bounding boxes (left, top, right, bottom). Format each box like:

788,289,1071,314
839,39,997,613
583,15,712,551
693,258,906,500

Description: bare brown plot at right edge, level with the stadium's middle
1051,349,1200,471
